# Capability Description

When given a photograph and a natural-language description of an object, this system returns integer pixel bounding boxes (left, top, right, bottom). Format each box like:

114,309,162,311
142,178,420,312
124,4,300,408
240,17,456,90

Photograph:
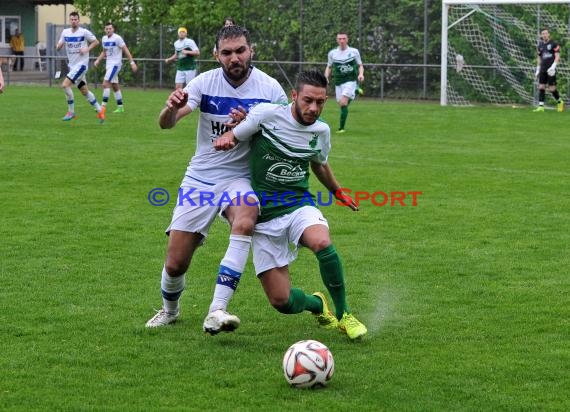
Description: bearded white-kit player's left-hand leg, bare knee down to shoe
146,230,204,328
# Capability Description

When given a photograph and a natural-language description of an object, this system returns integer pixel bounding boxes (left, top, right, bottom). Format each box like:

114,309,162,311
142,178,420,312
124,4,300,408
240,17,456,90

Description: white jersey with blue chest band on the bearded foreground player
184,68,287,183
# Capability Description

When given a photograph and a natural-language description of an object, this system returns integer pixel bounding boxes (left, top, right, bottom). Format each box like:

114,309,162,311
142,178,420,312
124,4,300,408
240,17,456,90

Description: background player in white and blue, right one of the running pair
93,22,137,113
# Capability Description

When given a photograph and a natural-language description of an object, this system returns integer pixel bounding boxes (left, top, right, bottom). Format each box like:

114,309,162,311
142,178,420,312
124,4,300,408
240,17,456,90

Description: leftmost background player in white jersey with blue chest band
56,11,105,123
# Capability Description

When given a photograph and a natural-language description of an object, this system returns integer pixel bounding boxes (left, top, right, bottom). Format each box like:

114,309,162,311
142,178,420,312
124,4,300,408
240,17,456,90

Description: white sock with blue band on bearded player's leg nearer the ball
209,235,251,312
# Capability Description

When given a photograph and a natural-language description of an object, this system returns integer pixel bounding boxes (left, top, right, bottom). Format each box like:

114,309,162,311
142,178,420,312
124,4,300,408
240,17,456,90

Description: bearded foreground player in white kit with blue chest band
146,26,287,335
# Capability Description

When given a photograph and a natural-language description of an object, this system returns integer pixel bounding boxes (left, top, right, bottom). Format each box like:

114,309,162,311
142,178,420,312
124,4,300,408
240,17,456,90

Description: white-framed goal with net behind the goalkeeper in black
441,0,570,105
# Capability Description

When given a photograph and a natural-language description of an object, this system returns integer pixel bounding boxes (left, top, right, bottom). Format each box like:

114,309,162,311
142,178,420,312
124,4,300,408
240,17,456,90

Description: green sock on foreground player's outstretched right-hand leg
315,245,350,319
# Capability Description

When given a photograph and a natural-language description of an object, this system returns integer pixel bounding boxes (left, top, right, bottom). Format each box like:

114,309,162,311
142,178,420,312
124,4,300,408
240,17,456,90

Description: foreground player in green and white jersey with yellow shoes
214,70,367,339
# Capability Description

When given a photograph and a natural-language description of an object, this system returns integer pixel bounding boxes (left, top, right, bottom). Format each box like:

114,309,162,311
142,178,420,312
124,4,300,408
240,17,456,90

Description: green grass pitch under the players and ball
0,86,570,411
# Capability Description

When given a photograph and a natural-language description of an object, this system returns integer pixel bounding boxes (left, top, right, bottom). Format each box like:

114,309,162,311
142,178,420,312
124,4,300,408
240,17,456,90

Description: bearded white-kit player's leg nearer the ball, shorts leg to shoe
203,179,259,335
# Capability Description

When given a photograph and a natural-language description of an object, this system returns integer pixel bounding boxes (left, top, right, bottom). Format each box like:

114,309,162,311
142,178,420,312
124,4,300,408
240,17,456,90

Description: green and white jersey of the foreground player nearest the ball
233,103,331,222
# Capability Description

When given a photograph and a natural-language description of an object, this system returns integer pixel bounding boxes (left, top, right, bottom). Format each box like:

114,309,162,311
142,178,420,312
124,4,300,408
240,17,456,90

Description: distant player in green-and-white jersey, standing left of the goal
325,32,364,133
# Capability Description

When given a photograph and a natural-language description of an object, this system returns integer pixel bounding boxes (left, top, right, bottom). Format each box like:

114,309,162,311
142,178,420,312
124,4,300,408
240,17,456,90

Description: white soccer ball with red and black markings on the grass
283,340,334,388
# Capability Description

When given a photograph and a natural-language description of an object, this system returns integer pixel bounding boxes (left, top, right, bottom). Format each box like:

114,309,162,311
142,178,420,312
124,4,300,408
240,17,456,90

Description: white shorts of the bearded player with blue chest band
166,177,259,237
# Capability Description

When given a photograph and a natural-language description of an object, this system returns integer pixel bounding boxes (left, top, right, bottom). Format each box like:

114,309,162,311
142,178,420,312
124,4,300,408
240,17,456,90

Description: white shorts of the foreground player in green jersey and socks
252,206,329,276
